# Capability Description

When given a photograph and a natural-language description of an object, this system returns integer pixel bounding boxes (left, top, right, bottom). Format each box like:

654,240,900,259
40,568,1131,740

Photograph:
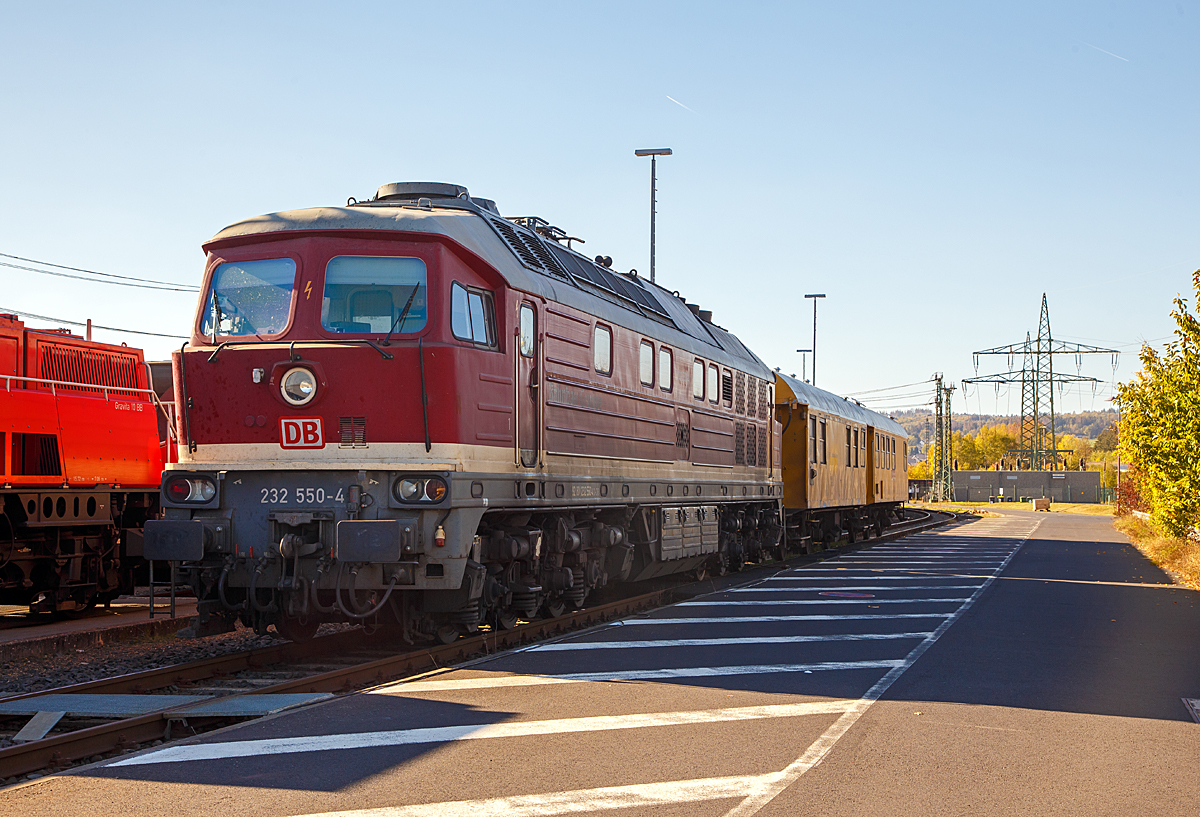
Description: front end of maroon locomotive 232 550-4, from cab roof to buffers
145,188,511,638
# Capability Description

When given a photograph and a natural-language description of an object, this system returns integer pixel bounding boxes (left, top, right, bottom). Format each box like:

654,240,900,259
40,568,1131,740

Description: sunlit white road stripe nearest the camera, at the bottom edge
288,774,778,817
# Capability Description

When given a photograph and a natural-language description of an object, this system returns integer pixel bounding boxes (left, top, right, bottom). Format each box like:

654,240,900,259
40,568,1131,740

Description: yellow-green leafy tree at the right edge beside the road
1118,270,1200,536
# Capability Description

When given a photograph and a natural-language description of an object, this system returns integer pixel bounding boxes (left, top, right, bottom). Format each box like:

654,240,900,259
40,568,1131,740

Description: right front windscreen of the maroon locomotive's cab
320,256,427,335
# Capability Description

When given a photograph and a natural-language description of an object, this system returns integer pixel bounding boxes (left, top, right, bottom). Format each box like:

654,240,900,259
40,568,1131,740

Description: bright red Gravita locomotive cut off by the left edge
0,314,167,612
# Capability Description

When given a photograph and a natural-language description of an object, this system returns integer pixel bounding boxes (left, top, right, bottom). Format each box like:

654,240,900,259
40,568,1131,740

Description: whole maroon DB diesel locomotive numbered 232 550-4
145,184,782,639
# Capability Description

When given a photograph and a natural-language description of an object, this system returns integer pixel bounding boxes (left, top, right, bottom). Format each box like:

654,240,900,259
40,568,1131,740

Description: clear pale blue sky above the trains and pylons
0,0,1200,411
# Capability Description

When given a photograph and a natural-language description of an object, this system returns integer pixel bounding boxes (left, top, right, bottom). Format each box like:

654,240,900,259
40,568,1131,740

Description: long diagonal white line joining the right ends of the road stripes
725,519,1042,817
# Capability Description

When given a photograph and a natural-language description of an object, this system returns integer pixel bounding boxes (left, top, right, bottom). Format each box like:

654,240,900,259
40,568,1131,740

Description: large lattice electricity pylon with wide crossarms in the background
962,293,1120,471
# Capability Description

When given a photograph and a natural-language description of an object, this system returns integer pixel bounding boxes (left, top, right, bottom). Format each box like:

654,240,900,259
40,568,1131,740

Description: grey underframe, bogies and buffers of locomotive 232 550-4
146,469,782,639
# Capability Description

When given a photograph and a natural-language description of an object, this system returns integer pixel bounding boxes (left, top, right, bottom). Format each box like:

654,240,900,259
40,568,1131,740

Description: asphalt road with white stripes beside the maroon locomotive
0,511,1200,817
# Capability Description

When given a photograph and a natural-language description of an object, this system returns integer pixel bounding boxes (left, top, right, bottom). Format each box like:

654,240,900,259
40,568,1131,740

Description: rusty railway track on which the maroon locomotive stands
0,510,956,782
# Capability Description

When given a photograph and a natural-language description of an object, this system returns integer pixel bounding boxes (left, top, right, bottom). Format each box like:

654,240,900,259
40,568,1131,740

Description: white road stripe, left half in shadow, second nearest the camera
109,701,854,767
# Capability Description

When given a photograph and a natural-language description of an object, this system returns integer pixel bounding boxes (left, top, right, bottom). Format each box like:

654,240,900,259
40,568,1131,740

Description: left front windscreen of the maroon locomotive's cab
200,258,296,336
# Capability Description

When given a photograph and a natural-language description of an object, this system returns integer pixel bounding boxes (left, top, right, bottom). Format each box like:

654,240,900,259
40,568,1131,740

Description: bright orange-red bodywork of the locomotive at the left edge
0,316,163,489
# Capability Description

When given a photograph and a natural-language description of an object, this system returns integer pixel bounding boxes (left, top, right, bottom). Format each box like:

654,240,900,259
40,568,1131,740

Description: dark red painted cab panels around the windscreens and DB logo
174,232,514,447
